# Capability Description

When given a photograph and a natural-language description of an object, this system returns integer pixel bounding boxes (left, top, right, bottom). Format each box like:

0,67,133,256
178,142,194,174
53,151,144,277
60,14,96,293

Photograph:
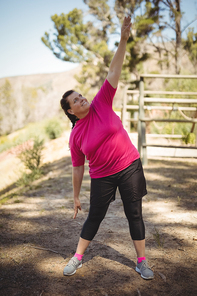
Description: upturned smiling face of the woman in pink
67,91,90,119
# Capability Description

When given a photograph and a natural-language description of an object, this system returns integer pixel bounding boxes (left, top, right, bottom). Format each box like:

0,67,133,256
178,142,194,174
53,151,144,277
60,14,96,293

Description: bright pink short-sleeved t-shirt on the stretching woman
69,79,140,178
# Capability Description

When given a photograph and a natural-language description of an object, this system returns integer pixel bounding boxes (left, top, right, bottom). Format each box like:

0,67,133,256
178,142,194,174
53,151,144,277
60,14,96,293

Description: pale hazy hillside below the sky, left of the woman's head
0,66,81,134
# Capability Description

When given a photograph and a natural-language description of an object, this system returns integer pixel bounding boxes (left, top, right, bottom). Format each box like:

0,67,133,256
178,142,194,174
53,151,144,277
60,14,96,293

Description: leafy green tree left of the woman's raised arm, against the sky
42,4,114,92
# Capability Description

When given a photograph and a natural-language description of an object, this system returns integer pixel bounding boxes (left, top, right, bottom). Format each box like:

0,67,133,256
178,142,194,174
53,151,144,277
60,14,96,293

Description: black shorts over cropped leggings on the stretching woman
81,159,147,241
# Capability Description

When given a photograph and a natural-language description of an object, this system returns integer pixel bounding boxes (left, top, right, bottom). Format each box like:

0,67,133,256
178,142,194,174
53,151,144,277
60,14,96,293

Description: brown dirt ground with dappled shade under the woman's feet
0,138,197,296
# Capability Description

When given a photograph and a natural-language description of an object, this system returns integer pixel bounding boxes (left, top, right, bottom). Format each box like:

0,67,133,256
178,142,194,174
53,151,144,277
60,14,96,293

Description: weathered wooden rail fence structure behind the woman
122,74,197,164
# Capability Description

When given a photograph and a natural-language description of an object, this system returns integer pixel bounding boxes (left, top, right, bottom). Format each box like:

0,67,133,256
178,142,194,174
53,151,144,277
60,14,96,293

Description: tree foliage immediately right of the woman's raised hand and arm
115,0,162,79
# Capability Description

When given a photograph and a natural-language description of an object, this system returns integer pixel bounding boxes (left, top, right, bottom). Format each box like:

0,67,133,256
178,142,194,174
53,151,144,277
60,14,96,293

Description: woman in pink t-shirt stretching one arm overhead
61,17,153,279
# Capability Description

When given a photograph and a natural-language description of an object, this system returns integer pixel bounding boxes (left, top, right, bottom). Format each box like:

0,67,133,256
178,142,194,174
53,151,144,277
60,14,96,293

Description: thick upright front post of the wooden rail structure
138,77,147,165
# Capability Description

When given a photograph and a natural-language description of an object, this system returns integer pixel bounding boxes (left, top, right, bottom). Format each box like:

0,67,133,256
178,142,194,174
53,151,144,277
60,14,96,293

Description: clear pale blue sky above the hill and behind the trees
0,0,197,78
